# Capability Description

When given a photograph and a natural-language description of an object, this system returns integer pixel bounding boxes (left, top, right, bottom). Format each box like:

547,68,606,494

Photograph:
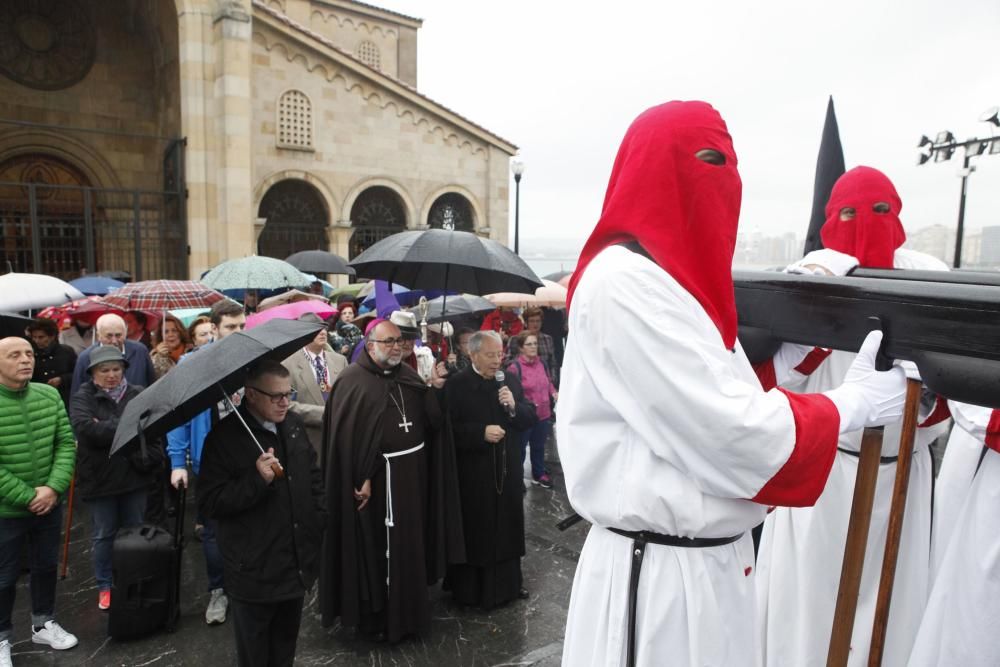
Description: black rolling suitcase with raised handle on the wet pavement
108,487,185,639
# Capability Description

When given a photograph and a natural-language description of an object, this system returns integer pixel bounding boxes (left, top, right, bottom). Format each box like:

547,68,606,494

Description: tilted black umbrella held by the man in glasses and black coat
110,319,325,454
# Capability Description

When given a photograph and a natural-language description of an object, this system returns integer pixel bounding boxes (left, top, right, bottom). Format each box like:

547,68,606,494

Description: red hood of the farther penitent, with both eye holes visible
820,167,906,269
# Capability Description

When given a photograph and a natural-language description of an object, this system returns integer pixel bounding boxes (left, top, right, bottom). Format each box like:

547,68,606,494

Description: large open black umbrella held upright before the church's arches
351,229,542,294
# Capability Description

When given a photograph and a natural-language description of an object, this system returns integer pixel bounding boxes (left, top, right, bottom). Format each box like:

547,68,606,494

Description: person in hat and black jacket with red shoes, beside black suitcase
70,346,162,610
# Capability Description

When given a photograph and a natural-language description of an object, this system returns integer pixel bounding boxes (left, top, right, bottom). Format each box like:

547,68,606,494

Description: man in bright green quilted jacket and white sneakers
0,337,77,667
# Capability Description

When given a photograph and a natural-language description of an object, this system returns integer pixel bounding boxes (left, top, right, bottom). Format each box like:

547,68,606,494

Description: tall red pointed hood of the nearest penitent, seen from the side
567,102,742,348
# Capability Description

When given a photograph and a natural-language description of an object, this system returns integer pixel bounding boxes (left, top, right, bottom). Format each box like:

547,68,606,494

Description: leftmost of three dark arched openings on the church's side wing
257,179,330,259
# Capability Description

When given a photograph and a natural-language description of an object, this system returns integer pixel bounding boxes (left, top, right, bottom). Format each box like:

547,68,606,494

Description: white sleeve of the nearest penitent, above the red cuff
576,264,795,498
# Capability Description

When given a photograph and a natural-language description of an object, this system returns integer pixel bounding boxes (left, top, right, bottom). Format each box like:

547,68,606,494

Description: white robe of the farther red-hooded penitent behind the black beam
756,245,947,667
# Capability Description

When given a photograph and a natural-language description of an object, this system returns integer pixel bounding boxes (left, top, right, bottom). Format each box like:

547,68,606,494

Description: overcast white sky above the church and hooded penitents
371,0,1000,250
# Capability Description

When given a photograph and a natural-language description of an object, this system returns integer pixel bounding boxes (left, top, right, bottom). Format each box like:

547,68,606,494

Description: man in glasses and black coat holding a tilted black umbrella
198,361,326,667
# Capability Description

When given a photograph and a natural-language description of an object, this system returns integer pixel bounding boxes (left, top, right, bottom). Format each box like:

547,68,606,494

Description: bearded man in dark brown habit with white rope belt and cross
320,322,465,641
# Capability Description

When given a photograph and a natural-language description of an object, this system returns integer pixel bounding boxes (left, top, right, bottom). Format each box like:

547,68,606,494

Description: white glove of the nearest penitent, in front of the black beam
823,331,906,433
